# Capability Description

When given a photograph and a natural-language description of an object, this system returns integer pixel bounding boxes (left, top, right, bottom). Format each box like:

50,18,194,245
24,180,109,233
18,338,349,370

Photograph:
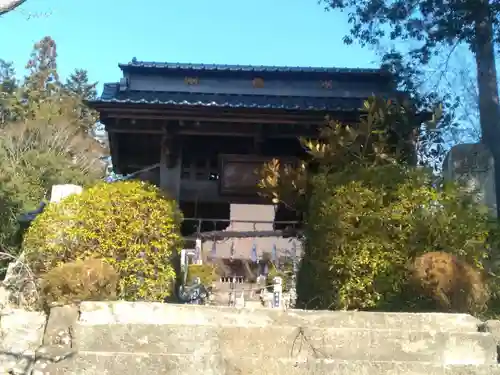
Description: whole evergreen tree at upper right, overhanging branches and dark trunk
322,0,500,217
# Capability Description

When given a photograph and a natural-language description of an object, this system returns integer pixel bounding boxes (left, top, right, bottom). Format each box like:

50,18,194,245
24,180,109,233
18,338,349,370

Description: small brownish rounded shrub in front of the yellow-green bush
40,259,119,308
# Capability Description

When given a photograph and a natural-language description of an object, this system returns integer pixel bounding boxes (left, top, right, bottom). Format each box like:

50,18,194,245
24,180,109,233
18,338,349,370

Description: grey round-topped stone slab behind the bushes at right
443,143,497,216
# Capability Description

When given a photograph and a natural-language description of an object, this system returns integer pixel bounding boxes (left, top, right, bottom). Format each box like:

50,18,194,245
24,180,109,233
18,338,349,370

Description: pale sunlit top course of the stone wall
79,302,481,332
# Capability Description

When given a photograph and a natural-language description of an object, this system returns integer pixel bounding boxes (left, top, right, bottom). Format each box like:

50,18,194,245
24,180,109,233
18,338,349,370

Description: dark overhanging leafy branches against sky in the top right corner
322,0,500,60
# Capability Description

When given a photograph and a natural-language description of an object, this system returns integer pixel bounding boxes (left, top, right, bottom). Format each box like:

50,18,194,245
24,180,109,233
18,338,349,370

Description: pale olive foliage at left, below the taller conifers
0,118,103,256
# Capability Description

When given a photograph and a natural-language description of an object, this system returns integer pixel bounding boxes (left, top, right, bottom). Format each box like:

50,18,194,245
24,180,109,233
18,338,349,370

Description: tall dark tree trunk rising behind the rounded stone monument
472,0,500,219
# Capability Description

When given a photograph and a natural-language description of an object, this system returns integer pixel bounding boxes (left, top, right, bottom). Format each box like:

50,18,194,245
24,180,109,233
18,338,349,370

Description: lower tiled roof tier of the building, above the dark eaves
90,84,364,111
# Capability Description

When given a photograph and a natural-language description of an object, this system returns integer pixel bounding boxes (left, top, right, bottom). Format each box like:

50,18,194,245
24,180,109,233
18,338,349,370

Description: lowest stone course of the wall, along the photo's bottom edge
37,352,500,375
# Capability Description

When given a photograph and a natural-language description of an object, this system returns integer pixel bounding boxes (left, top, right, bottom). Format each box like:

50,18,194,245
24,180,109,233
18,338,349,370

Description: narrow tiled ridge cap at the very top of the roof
118,59,388,74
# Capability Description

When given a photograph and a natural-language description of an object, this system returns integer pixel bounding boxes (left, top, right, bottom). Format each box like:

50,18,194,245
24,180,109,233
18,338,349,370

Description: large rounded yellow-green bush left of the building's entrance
23,181,182,301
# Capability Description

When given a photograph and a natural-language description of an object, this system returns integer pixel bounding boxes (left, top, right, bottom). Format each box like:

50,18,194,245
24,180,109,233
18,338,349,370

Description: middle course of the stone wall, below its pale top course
74,324,497,364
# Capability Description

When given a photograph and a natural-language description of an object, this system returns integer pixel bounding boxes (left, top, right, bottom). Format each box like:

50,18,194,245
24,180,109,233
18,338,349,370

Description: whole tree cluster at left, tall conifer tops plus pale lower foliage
0,37,105,270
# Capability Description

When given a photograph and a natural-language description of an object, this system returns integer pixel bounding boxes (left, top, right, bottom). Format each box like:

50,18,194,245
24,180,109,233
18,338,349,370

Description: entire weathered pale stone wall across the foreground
0,302,500,375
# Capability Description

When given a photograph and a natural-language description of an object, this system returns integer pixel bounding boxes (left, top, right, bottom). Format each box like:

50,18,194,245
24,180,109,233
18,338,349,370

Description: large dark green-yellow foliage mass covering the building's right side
260,98,499,312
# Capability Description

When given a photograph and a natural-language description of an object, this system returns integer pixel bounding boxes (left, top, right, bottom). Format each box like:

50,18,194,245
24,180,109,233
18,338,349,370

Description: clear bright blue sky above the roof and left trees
0,0,378,94
